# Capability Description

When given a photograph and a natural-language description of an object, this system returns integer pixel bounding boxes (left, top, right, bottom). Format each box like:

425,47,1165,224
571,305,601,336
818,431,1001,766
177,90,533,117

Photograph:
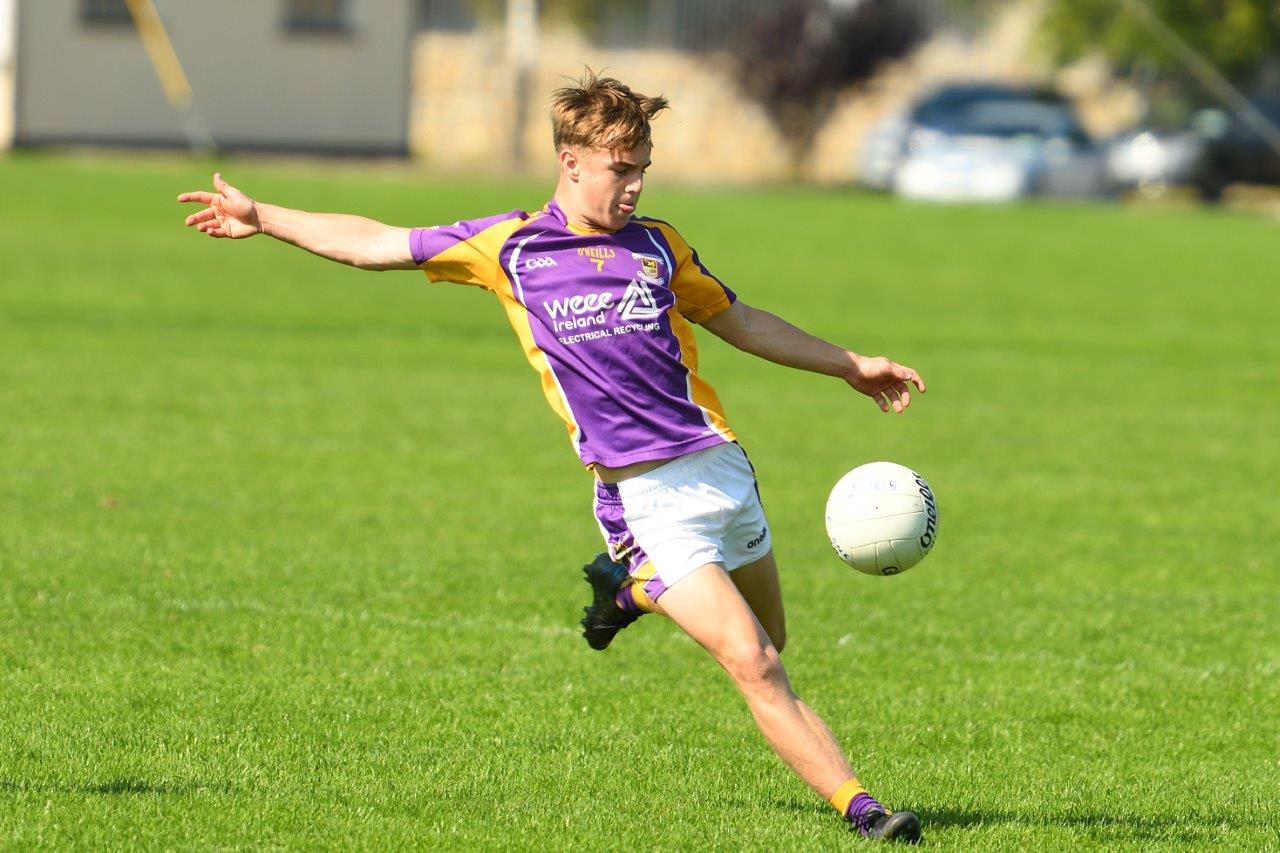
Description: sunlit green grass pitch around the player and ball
0,155,1280,850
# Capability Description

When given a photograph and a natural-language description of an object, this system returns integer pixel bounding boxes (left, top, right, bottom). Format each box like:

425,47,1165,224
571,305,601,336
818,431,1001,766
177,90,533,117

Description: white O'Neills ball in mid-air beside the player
827,462,938,575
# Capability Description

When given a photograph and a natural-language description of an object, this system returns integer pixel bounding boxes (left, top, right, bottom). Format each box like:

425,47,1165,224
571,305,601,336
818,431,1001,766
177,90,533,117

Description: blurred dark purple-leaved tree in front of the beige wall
733,0,927,174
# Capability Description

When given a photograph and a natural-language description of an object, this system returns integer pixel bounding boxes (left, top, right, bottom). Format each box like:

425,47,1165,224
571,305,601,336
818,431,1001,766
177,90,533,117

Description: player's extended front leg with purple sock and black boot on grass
655,564,920,841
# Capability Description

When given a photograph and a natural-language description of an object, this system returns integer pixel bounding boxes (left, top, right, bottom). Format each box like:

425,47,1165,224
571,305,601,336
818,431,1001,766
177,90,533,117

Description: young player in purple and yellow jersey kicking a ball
178,73,924,841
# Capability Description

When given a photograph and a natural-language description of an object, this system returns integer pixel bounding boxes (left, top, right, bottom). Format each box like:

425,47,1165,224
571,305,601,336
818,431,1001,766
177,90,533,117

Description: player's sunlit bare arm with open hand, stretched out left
178,174,417,269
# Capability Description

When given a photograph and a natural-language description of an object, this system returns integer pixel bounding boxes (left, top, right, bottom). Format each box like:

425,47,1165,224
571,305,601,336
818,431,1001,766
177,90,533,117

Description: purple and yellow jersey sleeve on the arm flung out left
408,210,527,291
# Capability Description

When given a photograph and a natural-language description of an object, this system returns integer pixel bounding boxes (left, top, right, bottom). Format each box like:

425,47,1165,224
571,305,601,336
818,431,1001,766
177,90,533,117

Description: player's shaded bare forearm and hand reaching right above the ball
703,300,924,412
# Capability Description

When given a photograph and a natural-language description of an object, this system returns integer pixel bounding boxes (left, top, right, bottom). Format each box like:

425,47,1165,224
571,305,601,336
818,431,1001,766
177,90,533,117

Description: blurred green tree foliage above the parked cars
1044,0,1280,83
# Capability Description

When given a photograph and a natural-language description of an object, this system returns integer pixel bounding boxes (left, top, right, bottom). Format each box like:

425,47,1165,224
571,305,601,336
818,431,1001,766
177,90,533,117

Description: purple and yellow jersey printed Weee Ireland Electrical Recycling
410,201,736,467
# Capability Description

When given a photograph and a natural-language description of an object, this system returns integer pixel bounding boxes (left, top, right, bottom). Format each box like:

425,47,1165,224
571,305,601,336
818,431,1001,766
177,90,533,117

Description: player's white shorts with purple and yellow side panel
595,444,773,601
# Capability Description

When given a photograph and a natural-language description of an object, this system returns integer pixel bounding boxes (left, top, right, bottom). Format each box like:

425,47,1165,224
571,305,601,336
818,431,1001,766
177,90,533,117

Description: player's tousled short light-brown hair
552,68,667,151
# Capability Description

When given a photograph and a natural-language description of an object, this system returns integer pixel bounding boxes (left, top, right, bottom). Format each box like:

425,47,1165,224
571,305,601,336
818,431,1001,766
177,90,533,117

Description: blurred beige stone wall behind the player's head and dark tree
410,0,1140,184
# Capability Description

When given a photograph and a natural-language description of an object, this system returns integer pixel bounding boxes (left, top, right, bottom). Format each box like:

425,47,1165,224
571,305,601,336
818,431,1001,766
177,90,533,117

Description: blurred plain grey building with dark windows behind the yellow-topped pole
12,0,415,154
